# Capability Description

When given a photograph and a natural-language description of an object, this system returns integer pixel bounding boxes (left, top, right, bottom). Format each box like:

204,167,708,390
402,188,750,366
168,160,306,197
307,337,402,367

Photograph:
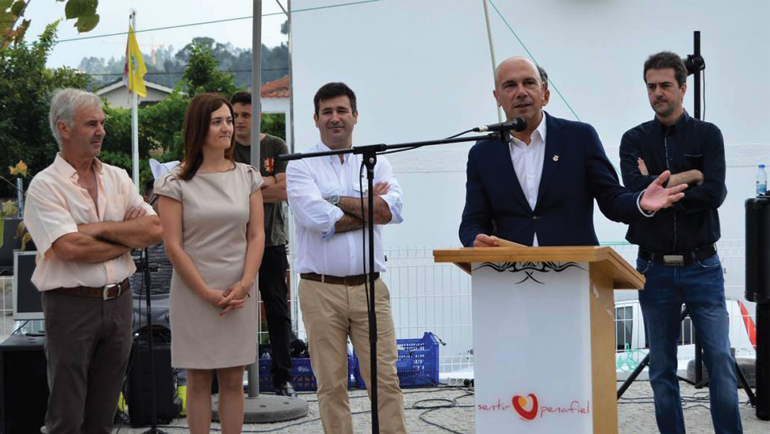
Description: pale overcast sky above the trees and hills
24,0,286,67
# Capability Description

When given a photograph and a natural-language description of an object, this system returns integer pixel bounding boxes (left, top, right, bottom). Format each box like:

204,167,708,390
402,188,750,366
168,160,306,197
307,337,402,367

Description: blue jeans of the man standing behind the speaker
636,255,743,434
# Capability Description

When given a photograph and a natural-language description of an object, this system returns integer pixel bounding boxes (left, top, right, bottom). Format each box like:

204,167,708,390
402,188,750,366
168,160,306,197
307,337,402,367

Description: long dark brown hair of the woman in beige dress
179,93,235,181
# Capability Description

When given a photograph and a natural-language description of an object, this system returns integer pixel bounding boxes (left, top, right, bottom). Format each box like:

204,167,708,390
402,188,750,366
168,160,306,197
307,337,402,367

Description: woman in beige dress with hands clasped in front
155,94,265,434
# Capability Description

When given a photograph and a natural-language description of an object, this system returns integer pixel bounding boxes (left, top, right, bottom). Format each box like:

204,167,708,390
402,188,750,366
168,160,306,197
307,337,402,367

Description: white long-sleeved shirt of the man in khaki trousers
286,143,403,277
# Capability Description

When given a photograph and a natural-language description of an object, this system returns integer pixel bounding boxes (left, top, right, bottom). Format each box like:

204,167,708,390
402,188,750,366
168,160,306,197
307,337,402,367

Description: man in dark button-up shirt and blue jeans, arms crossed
620,52,743,434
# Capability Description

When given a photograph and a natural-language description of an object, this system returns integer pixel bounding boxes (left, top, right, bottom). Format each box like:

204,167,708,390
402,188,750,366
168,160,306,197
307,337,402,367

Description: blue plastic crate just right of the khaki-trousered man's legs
353,332,439,389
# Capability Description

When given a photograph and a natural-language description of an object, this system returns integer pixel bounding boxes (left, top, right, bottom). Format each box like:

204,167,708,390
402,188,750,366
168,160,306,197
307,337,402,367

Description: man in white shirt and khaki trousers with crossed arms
286,83,406,434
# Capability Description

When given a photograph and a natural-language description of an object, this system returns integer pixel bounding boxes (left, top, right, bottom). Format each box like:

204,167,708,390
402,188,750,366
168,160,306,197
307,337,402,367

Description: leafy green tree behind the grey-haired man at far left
0,23,89,197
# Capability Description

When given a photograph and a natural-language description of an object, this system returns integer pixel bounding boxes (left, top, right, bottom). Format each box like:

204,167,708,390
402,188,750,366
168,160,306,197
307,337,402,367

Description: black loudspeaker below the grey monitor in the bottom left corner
0,335,48,434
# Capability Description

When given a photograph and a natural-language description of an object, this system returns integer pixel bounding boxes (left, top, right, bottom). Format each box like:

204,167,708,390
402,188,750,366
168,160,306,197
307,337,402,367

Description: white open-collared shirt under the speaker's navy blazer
508,112,546,246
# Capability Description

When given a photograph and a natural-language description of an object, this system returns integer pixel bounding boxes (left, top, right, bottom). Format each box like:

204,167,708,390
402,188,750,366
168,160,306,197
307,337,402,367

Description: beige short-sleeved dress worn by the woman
155,163,263,369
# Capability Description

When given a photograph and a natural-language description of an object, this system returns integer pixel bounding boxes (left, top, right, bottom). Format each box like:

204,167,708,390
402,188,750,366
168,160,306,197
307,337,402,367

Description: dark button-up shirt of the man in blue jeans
620,100,727,253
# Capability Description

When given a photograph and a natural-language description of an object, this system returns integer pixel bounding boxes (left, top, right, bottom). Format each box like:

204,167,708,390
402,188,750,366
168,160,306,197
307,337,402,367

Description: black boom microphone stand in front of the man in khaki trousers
276,132,500,434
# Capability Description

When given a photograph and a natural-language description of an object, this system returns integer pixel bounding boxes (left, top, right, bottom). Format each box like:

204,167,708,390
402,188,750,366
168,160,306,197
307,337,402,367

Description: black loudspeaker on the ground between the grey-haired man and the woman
126,334,179,427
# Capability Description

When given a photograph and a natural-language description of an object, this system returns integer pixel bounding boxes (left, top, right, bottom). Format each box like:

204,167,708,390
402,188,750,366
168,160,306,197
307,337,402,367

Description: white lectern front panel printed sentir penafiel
472,262,593,434
